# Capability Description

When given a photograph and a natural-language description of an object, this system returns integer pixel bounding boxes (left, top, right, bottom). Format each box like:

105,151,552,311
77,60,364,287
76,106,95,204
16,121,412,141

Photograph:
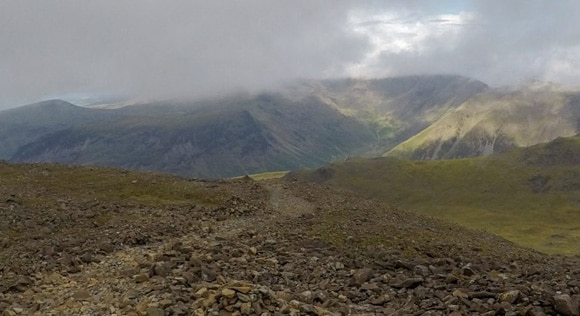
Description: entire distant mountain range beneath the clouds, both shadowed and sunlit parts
7,75,580,178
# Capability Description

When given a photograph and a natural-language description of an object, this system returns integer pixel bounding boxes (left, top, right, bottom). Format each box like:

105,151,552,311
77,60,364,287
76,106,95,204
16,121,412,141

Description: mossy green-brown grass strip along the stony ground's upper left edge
0,161,227,207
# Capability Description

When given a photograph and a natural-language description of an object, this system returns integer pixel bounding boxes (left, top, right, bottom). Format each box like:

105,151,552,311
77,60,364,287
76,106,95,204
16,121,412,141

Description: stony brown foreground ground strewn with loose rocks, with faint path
0,164,580,316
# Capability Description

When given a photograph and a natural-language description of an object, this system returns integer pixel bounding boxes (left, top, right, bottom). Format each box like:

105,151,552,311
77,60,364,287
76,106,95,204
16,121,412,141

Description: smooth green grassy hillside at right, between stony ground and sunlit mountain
286,137,580,254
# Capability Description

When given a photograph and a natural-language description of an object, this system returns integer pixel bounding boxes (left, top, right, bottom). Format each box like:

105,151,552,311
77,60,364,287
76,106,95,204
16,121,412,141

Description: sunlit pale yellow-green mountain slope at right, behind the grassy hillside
386,85,580,160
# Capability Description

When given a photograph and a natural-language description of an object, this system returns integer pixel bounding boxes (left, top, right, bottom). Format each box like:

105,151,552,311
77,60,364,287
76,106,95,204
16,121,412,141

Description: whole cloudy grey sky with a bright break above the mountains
0,0,580,108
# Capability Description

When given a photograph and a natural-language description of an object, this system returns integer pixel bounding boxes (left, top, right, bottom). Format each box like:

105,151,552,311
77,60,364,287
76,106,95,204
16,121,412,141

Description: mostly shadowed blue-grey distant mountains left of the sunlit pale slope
0,76,487,178
